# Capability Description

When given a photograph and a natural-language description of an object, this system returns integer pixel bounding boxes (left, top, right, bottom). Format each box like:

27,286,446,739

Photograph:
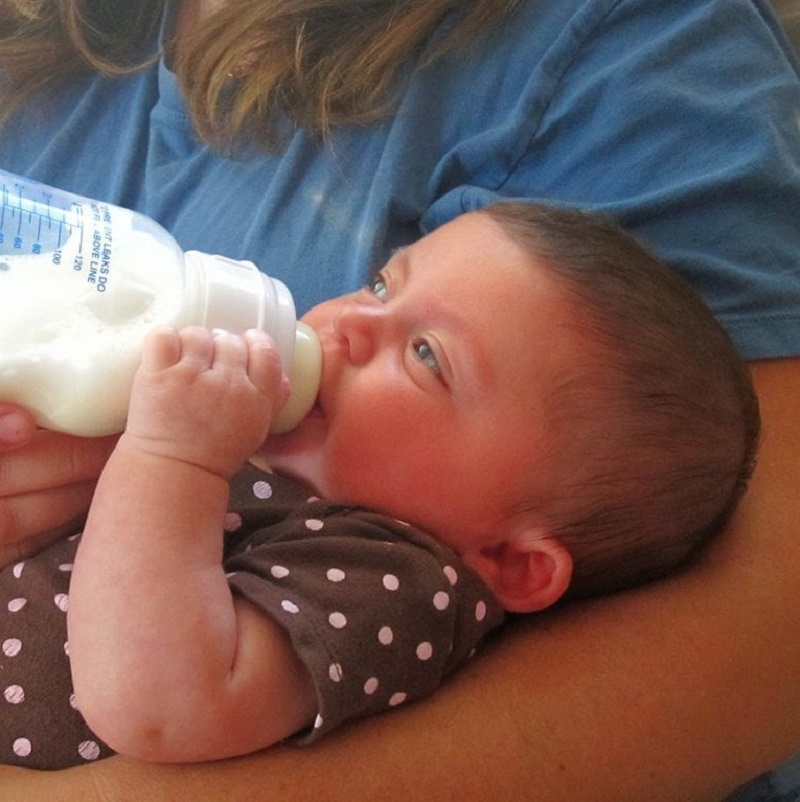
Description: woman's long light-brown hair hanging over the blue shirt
0,0,518,149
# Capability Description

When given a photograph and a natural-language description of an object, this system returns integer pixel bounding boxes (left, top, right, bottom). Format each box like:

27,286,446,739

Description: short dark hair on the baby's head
482,202,760,598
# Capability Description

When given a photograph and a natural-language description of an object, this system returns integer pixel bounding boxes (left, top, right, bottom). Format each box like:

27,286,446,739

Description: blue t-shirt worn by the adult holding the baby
0,0,800,358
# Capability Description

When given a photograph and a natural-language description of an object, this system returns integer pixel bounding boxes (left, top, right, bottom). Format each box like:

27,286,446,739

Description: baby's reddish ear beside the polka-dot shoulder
464,530,572,613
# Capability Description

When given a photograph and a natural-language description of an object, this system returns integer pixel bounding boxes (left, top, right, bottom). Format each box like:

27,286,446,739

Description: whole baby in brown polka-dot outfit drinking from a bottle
0,203,758,768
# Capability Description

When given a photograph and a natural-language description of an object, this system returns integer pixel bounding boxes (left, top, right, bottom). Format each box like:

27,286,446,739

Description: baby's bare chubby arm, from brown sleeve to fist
68,328,315,761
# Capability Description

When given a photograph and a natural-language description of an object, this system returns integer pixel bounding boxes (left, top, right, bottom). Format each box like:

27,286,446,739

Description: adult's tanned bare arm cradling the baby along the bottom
0,359,800,802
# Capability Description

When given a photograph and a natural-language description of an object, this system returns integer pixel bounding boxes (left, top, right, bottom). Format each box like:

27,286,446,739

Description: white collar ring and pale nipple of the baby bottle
185,251,322,432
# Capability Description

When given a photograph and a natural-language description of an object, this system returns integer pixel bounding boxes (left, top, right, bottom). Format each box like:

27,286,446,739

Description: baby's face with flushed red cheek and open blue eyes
265,213,575,555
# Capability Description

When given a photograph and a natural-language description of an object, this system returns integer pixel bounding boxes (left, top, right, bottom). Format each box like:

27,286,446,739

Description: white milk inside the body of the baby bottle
0,225,183,434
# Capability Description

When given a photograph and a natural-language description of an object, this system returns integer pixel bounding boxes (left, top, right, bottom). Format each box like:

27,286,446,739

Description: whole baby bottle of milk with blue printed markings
0,166,322,437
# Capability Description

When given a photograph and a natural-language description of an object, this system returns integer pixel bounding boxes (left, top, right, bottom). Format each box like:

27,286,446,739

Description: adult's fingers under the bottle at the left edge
0,403,116,565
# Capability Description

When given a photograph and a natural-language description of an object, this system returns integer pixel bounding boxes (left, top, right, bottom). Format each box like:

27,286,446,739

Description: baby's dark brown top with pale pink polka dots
0,465,503,769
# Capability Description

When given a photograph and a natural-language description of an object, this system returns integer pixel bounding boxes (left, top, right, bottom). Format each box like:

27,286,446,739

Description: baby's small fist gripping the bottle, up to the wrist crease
124,327,289,479
